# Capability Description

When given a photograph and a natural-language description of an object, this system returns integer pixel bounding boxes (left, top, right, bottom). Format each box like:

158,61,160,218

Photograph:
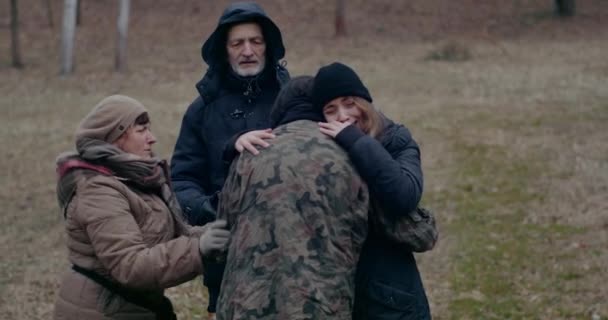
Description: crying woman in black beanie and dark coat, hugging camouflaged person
312,63,431,320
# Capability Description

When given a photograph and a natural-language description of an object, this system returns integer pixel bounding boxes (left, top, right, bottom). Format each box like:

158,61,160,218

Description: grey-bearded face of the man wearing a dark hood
226,22,266,77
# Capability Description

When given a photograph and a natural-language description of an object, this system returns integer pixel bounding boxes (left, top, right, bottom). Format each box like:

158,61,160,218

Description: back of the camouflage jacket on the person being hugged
217,120,369,320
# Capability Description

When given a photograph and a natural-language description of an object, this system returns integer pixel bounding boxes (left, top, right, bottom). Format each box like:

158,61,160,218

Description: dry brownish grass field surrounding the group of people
0,0,608,320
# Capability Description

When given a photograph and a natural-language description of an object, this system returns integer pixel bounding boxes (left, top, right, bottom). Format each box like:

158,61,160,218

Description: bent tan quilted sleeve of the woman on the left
75,177,203,290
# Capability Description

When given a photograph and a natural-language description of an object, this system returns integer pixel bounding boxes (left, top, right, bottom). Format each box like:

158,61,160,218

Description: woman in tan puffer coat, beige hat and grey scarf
54,95,229,319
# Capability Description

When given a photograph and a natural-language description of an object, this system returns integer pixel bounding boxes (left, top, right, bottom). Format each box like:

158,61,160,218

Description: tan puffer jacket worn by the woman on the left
54,175,204,320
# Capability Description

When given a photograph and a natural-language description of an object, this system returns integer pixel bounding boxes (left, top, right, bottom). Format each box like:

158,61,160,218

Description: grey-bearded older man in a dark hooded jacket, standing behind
171,2,289,312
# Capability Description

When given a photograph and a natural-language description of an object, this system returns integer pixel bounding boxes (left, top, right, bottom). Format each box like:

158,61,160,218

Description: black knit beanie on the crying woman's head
312,62,372,110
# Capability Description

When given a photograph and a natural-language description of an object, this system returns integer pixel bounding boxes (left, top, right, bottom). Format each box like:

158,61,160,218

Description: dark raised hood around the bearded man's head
201,2,285,68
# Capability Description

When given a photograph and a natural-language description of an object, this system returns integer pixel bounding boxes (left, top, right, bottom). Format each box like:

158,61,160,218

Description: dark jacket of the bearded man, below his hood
171,65,289,225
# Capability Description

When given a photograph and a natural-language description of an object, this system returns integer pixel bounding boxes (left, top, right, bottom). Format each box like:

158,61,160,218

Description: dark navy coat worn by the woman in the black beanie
336,119,431,320
